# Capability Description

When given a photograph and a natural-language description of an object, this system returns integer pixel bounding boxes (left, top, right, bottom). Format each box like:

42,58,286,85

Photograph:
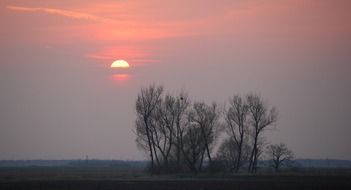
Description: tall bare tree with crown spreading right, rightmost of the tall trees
246,94,278,173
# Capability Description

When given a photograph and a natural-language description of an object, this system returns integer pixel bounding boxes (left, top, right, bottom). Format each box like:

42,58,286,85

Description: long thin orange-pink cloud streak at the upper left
6,5,113,22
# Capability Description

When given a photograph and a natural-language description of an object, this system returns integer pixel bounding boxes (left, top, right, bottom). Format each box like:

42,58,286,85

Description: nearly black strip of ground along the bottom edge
0,177,351,190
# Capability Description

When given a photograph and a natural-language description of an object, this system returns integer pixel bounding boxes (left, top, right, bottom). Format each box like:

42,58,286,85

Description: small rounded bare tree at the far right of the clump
267,143,294,172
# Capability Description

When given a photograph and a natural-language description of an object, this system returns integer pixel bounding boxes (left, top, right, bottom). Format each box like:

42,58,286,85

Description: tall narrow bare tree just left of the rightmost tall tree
224,95,249,172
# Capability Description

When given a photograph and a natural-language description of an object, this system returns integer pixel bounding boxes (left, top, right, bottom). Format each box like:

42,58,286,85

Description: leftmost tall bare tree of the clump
135,85,163,171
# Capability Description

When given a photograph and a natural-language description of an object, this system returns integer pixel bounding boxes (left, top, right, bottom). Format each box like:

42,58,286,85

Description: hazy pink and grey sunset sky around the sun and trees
0,0,351,160
